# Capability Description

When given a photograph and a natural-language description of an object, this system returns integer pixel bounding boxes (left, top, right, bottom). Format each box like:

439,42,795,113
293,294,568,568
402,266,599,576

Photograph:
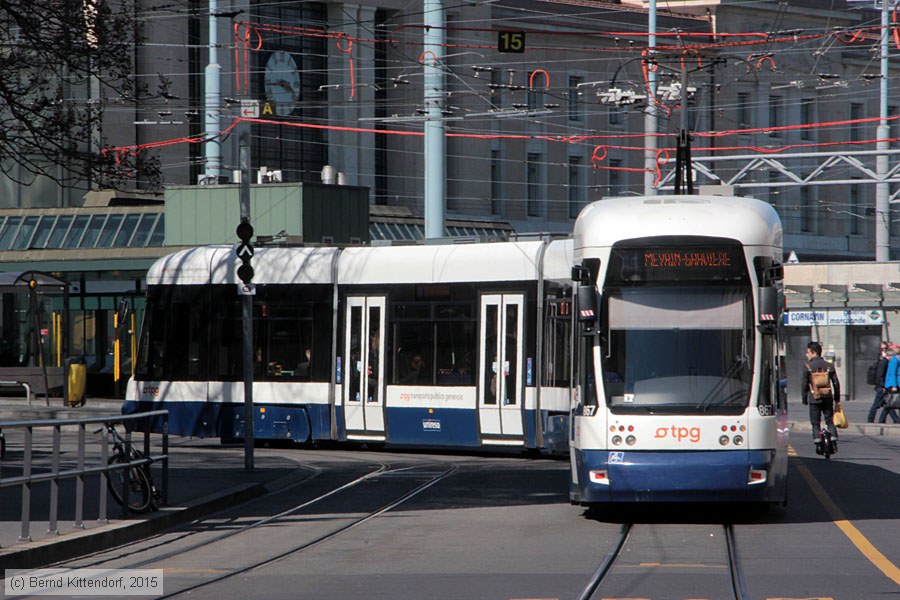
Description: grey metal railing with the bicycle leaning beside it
0,410,169,542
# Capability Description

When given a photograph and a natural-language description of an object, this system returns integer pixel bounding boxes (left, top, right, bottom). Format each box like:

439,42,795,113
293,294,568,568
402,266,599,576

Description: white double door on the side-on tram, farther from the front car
343,296,385,439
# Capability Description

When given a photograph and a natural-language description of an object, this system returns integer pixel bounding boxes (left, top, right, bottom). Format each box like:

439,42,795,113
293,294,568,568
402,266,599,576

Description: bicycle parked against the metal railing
94,423,160,514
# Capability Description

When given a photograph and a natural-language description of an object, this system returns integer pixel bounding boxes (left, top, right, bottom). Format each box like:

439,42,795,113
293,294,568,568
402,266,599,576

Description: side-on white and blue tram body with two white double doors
124,238,574,452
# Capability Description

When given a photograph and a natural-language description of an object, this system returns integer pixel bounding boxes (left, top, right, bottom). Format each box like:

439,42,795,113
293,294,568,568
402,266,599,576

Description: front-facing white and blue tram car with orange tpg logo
569,196,787,505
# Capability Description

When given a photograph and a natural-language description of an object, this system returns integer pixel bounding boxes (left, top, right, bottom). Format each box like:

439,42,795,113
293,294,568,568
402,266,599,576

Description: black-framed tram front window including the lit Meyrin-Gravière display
600,239,754,414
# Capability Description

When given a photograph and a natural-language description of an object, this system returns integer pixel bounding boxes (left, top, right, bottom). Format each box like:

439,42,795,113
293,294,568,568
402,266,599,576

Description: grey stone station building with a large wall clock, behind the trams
7,0,900,261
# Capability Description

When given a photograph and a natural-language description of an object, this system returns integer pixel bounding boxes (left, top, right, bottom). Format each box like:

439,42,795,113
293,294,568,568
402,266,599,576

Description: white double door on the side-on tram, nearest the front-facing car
478,294,525,442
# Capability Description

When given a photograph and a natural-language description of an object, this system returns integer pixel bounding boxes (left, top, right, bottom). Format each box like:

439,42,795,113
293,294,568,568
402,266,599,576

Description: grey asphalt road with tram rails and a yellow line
22,435,900,600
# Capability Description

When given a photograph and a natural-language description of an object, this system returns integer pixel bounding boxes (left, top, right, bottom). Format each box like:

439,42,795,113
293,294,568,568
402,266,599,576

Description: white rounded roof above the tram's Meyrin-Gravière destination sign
575,196,782,251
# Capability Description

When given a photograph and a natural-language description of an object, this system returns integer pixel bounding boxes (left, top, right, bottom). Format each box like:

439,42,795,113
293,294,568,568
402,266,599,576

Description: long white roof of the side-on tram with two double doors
147,239,572,285
